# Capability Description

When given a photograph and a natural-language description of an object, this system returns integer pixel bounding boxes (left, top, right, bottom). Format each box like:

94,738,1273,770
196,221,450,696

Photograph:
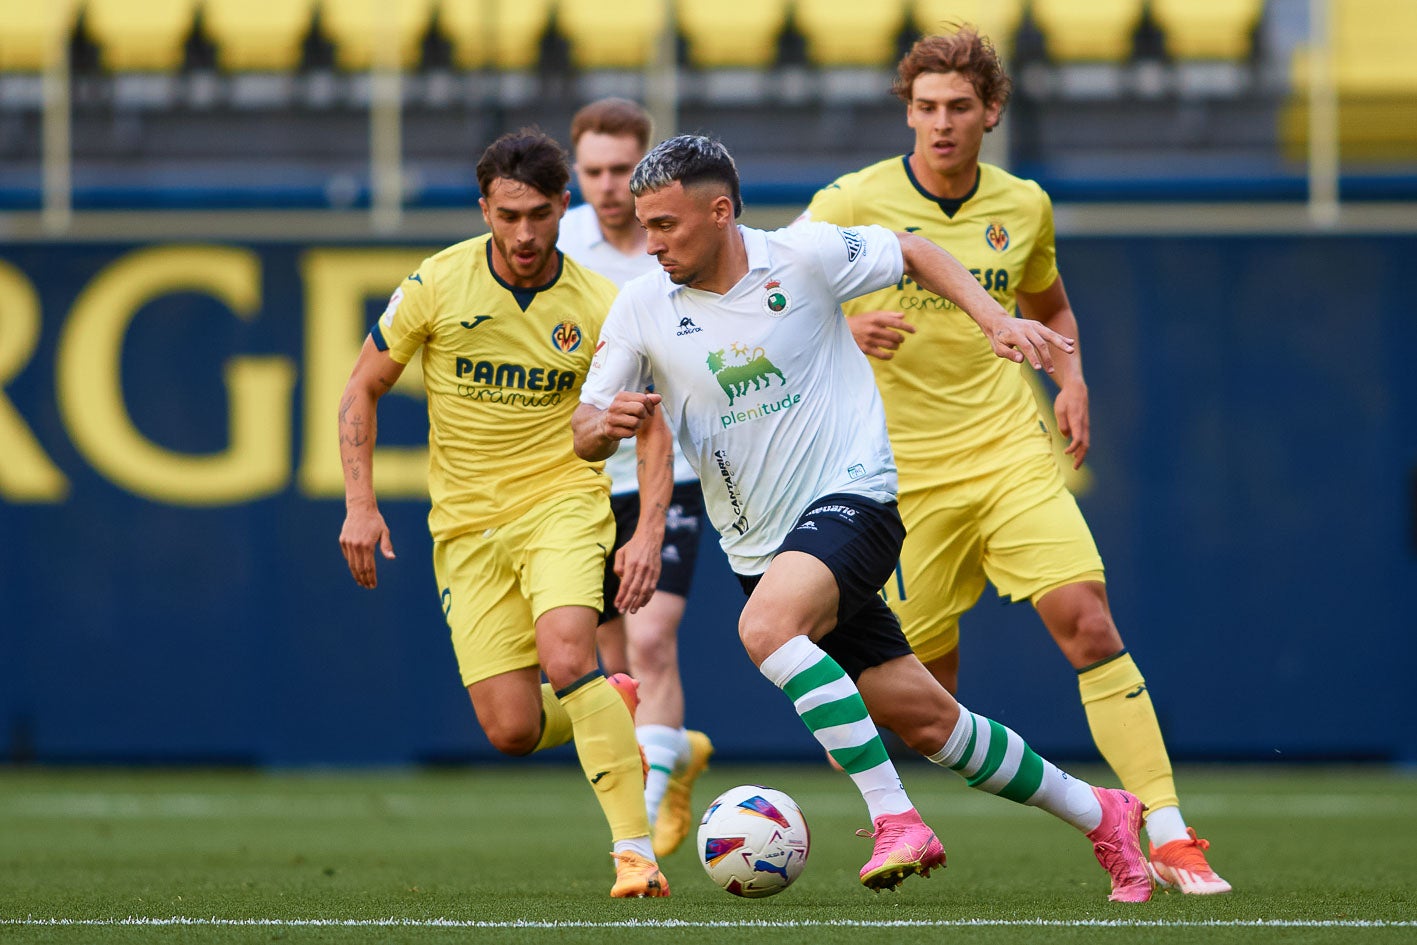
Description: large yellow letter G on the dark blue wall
55,247,295,506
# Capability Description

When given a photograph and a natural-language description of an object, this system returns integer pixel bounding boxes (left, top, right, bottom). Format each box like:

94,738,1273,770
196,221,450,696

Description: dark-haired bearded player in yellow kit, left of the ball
339,132,670,898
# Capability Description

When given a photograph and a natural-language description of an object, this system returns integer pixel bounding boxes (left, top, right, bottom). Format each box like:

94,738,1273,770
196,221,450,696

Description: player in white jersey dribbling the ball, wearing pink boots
571,135,1152,902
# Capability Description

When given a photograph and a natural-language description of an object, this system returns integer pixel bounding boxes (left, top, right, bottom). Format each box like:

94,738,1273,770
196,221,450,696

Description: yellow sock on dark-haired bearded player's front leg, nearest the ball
557,670,649,840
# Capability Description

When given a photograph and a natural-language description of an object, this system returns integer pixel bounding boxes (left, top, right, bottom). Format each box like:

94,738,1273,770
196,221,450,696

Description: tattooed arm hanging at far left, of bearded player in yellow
331,337,404,588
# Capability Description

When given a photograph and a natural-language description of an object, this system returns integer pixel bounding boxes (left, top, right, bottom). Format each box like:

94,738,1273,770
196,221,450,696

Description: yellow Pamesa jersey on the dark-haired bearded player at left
371,235,615,540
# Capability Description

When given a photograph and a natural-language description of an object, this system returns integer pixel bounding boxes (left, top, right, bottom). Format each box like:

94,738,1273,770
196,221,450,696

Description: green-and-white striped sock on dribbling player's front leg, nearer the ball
758,636,914,820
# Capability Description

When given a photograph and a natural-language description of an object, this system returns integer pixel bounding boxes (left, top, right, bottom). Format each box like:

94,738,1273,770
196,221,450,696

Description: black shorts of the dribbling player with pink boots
738,493,911,680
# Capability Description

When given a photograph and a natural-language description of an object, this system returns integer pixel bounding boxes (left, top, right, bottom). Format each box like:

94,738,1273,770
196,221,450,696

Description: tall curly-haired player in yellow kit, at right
803,27,1230,894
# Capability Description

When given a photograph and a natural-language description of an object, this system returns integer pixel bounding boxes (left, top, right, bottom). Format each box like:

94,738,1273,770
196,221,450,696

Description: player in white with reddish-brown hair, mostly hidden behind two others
557,98,713,857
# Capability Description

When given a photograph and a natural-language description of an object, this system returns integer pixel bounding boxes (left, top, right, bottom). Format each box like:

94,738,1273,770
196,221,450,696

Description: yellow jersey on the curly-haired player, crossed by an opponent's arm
808,154,1058,487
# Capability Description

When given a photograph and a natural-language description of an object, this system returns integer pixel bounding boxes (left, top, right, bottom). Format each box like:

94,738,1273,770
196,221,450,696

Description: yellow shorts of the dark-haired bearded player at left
434,492,615,686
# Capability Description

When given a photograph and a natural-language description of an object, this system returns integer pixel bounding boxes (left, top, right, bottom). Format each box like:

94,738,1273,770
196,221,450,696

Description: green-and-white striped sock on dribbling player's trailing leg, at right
927,706,1102,833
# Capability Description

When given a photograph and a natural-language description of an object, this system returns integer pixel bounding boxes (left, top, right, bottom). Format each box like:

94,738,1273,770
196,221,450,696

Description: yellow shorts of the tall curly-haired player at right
884,438,1104,663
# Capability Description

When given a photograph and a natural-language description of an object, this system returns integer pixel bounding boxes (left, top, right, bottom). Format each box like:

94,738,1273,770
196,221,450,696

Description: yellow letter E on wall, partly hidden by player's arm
299,249,428,499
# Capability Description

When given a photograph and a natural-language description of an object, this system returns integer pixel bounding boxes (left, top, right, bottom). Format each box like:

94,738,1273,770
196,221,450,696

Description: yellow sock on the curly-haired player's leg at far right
1077,650,1180,810
